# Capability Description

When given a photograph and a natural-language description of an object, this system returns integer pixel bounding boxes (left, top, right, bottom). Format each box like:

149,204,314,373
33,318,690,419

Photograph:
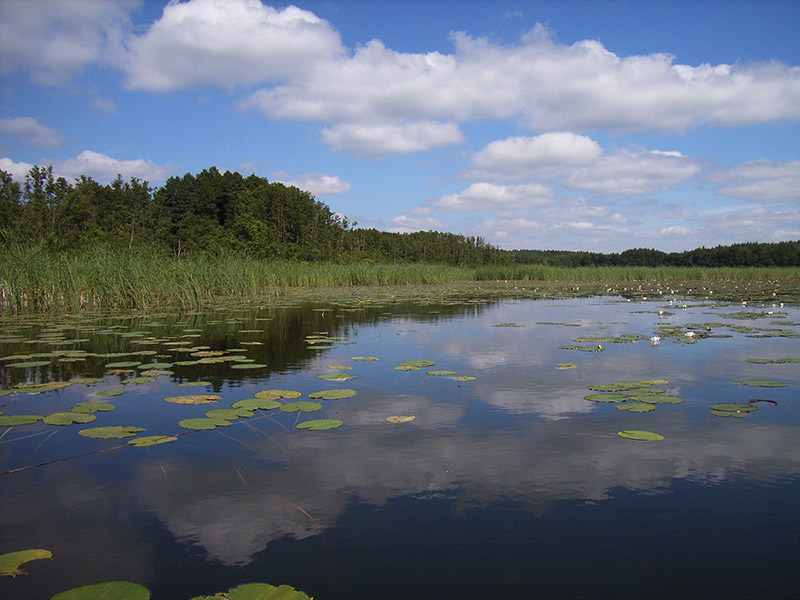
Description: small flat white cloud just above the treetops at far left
48,150,172,183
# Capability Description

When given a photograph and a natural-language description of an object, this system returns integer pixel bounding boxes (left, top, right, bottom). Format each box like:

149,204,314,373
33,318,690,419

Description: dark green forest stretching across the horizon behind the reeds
0,166,800,267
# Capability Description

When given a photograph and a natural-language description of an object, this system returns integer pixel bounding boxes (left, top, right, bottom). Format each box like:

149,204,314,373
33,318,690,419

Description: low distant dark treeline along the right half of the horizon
506,240,800,267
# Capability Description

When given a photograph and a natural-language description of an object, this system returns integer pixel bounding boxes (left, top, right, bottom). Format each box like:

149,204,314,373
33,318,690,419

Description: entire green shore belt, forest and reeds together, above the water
0,166,800,315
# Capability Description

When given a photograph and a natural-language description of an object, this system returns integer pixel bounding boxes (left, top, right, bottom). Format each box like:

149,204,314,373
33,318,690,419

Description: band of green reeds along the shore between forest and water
0,247,800,315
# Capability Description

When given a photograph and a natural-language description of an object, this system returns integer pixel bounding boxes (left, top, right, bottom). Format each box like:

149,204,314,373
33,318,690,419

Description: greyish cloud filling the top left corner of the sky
0,0,139,85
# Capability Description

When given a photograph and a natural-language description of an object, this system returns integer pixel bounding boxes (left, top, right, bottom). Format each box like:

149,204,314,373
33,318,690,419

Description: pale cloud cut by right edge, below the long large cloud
706,160,800,202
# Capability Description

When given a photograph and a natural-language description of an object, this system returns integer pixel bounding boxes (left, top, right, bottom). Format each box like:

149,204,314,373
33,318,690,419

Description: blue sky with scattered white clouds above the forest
0,0,800,252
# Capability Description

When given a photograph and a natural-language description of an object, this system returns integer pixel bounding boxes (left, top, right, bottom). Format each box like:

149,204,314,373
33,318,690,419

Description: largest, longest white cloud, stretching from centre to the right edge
246,26,800,131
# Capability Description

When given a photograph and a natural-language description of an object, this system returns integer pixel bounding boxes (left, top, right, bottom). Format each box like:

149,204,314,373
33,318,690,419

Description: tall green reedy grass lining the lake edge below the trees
0,245,800,314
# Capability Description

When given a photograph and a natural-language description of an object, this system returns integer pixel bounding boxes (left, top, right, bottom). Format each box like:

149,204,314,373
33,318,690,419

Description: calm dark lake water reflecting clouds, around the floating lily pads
0,290,800,600
